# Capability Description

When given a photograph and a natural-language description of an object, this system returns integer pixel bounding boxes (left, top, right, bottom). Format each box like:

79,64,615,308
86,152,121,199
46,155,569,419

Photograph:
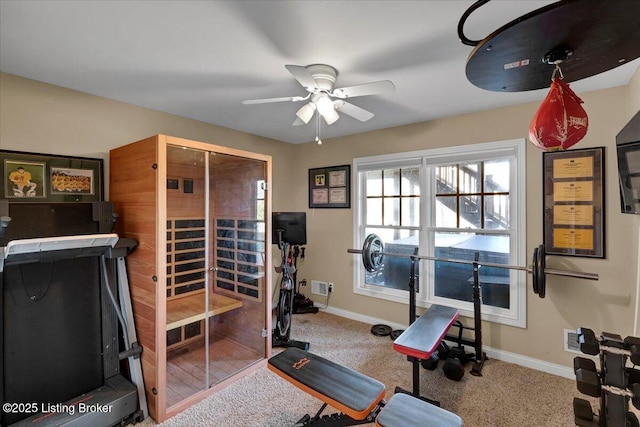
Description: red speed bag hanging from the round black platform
529,78,589,151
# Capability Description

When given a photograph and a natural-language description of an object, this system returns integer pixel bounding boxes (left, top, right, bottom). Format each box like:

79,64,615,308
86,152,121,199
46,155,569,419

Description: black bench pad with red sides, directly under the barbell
393,304,458,360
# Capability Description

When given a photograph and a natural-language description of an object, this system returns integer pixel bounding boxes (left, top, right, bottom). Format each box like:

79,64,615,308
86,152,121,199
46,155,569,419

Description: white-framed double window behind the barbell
354,140,526,326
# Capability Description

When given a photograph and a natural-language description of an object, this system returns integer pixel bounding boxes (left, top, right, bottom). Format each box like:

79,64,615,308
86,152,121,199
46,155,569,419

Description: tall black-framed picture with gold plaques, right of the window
542,147,605,258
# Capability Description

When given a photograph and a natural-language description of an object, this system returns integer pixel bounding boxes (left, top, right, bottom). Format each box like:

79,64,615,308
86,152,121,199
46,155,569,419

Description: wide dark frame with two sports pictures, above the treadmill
0,150,103,202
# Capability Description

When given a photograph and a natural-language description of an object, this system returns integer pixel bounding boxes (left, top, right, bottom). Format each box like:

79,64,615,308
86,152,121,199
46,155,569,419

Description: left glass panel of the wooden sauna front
166,145,210,407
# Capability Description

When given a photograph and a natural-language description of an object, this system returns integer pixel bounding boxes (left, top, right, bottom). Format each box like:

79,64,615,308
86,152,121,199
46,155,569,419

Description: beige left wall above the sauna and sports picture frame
0,73,293,209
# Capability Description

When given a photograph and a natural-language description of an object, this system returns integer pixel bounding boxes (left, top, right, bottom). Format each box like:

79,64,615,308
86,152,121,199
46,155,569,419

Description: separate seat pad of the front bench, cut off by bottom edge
376,393,462,427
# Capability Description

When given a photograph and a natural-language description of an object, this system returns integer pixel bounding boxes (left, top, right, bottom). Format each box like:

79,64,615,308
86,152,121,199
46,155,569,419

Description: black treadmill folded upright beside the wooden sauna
0,201,148,427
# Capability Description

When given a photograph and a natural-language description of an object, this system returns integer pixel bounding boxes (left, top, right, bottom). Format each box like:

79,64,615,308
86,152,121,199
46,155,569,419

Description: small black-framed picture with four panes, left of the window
309,165,351,208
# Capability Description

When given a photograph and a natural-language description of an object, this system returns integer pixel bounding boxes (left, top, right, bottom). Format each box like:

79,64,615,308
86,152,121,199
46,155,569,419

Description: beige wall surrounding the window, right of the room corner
293,67,638,366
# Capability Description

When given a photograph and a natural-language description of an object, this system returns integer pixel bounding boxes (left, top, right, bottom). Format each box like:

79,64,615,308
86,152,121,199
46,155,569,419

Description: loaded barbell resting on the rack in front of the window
347,233,599,298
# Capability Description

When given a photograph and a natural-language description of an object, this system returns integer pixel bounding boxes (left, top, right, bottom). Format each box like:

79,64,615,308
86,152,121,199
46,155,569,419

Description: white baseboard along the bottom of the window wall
321,307,576,379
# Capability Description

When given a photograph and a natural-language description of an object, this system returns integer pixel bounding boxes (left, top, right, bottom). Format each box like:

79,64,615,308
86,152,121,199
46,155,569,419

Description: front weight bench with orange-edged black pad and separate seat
268,347,462,427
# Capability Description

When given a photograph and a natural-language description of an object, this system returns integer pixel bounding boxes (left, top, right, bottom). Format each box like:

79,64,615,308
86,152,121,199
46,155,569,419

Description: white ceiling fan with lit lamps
242,64,396,126
